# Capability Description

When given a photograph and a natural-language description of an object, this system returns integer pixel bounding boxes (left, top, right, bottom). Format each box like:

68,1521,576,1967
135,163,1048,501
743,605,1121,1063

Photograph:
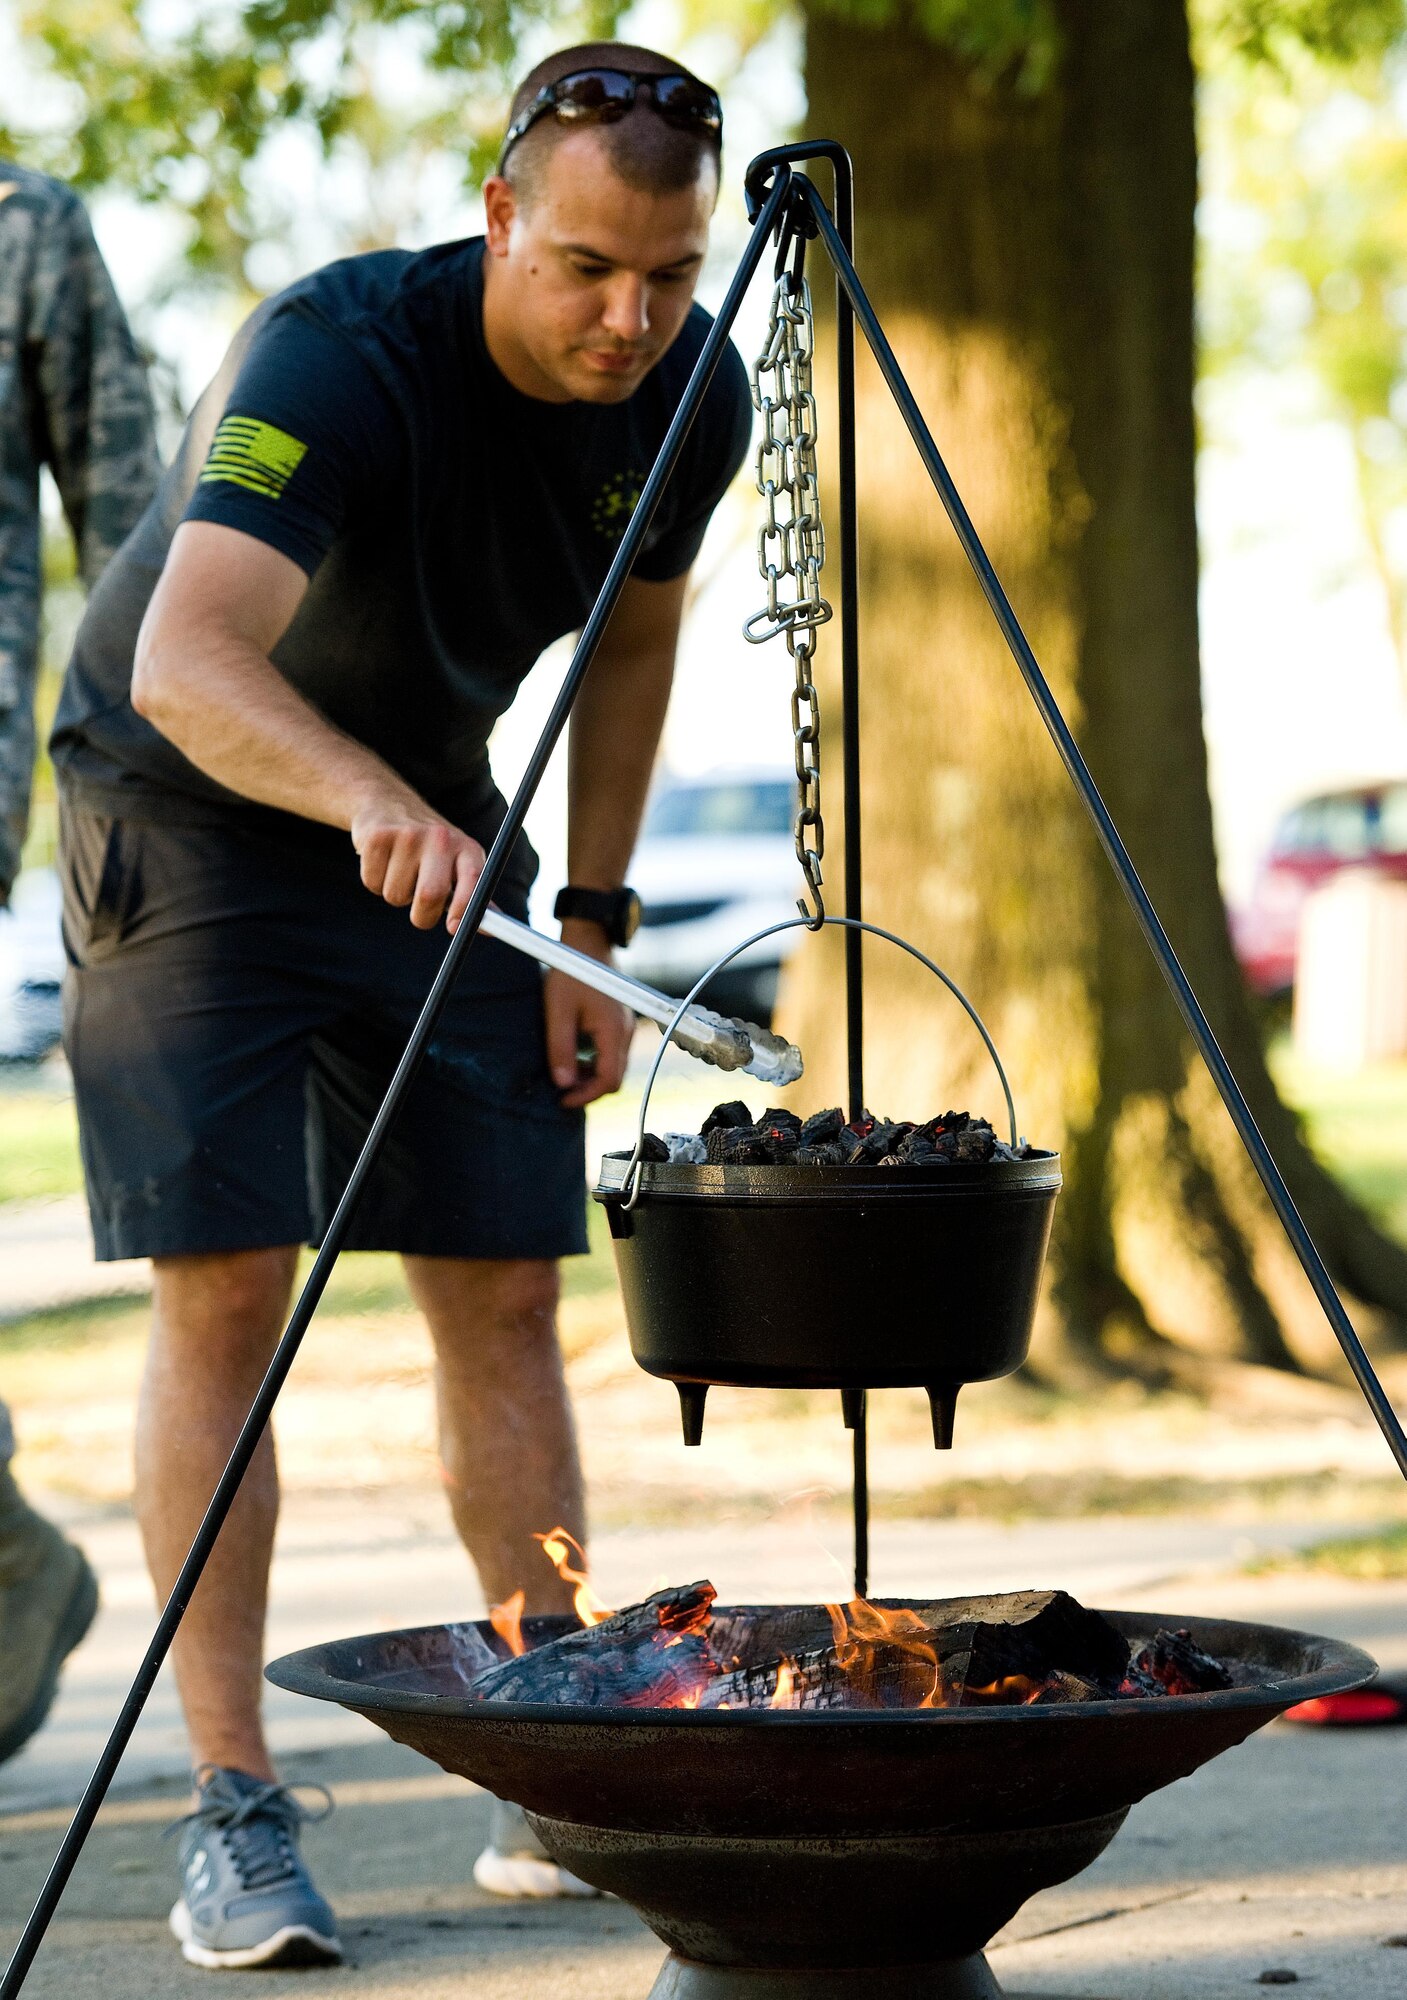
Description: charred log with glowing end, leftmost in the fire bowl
472,1582,721,1708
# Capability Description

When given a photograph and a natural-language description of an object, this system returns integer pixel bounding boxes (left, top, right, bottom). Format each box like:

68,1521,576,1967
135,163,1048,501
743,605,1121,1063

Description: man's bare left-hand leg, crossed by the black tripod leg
136,1246,298,1778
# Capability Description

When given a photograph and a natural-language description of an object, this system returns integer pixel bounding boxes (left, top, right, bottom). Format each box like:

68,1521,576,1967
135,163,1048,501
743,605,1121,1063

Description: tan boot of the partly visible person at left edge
0,1466,98,1764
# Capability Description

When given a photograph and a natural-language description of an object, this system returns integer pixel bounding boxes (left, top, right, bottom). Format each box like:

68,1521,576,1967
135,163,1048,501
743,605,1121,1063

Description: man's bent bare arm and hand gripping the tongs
132,520,484,930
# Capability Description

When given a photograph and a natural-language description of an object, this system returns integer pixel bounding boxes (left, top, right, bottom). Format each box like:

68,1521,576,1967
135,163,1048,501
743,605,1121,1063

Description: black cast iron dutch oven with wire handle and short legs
596,918,1061,1444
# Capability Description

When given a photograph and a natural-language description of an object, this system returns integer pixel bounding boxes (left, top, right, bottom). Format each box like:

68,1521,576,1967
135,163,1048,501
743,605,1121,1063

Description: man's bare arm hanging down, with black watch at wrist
546,576,688,1106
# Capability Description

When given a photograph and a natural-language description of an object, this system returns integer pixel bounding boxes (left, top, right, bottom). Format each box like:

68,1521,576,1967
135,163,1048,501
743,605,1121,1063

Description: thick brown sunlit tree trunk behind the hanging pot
783,0,1407,1366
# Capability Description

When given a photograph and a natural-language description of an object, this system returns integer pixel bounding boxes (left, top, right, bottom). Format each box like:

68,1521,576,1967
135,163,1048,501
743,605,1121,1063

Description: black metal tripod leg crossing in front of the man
0,170,787,2000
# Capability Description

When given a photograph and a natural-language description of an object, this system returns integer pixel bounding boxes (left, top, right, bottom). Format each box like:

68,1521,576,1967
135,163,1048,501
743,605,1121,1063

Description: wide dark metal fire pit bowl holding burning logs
268,1600,1375,2000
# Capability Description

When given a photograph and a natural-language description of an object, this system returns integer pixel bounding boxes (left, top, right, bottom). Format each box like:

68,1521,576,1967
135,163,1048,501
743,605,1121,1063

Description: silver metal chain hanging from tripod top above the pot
743,270,831,930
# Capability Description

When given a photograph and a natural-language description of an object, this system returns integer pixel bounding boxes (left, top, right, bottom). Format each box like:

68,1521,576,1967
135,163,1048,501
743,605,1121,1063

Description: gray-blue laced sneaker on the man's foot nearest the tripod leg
170,1764,342,1970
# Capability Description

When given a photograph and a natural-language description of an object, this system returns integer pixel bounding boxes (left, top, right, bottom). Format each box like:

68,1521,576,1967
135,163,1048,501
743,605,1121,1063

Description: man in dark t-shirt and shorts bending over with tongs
54,44,749,1966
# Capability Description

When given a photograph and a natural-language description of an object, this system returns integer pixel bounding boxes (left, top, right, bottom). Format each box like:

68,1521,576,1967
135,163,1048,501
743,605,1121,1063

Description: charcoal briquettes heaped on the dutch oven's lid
642,1098,1039,1168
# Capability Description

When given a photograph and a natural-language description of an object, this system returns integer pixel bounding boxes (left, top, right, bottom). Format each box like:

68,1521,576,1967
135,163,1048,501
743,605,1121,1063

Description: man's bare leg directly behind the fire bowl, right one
406,1256,586,1612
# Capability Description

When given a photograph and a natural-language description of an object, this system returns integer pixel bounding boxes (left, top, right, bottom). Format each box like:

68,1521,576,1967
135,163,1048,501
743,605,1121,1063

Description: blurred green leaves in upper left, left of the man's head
0,0,620,282
